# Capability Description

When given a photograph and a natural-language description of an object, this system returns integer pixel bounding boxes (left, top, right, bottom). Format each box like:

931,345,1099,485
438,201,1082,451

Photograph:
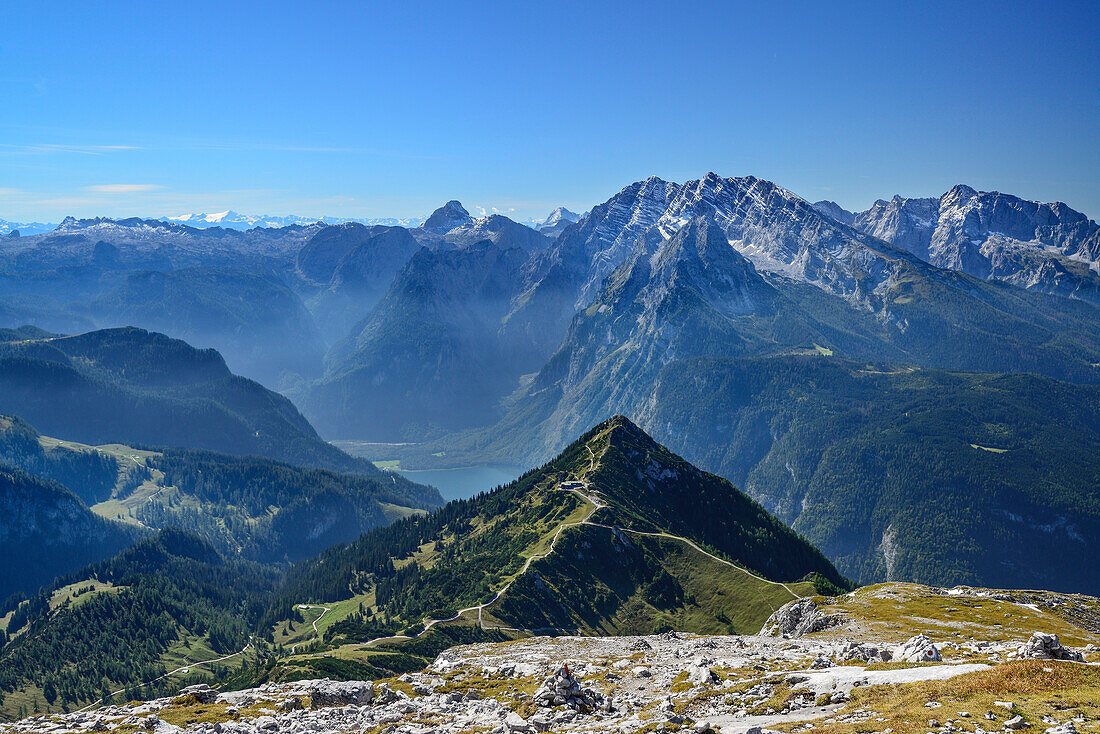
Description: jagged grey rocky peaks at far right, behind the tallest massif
855,185,1100,303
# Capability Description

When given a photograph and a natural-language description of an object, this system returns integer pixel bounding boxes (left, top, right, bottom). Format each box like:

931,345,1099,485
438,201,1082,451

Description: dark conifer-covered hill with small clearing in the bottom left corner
0,529,277,719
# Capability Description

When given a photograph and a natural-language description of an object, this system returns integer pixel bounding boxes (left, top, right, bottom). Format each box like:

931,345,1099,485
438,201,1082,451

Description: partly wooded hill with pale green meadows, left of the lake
0,416,439,567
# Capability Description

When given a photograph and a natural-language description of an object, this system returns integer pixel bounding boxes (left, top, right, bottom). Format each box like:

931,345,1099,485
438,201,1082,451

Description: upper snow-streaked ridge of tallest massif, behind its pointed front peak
517,174,1097,382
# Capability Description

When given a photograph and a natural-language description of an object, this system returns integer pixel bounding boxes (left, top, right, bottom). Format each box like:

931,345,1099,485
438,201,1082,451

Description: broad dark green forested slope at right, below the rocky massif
433,353,1100,593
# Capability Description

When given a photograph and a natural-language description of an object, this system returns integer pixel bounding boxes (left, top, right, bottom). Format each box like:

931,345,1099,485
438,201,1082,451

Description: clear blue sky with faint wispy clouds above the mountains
0,0,1100,221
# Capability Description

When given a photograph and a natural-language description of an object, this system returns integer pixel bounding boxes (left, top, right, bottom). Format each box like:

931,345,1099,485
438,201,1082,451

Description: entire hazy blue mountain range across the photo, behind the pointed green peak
0,174,1100,589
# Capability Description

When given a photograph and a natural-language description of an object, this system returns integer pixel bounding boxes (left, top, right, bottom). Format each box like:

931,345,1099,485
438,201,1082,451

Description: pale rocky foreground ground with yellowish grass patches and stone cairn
8,584,1100,734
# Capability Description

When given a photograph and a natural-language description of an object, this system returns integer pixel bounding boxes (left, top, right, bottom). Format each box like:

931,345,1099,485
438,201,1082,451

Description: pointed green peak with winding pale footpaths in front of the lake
261,417,848,682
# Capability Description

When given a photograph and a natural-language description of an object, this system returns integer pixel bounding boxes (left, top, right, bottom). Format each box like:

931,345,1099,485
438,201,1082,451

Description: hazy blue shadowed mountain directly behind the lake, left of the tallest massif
305,240,547,440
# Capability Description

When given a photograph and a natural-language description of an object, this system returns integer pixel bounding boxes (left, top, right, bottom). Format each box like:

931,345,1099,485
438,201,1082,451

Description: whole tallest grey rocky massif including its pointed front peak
319,174,1100,446
